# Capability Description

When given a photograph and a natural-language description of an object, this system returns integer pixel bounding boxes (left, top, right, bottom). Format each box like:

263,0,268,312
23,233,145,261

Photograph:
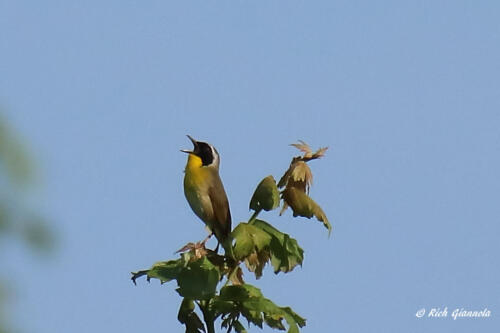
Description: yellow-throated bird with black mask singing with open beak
181,135,232,254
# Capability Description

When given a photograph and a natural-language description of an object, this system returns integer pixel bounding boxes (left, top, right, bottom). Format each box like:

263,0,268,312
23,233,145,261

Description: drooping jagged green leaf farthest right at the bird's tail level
253,220,304,273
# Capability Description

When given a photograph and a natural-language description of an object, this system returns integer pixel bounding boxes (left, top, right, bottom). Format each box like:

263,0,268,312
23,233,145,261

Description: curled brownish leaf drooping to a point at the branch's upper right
281,186,332,235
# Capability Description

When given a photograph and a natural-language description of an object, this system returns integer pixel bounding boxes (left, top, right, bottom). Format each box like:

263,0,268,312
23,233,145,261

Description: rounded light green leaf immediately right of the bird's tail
231,223,271,260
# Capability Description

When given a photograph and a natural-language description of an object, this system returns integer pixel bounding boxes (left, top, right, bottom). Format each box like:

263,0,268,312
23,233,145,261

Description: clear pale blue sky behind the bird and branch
0,1,500,333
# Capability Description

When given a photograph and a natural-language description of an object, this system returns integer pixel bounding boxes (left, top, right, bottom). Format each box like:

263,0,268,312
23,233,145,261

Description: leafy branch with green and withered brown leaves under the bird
132,141,332,333
